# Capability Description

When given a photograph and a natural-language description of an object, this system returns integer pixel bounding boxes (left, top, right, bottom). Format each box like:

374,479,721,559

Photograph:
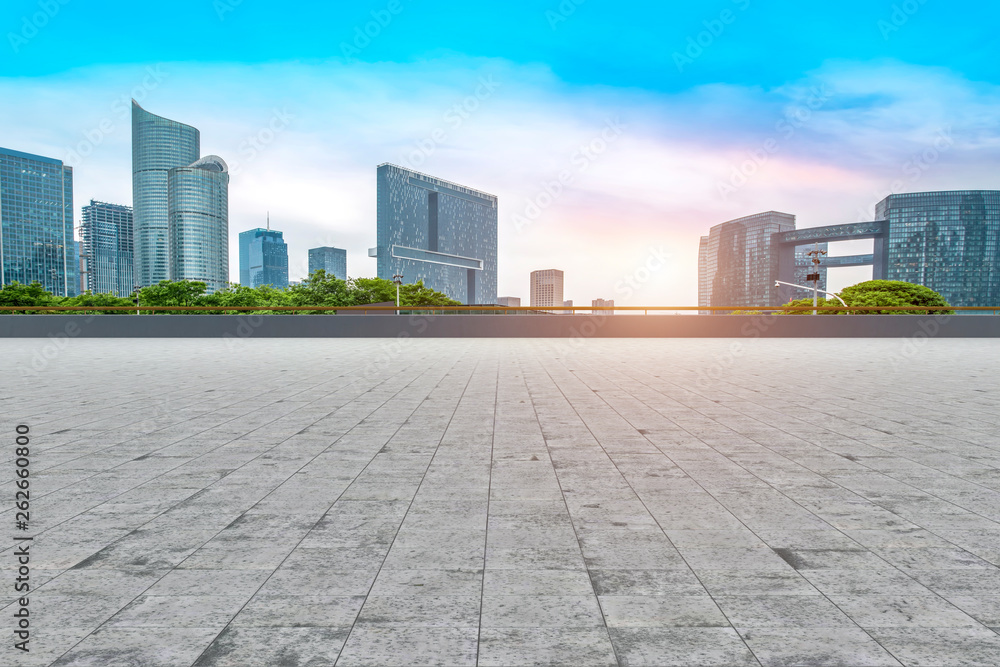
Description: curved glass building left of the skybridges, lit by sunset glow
698,211,795,308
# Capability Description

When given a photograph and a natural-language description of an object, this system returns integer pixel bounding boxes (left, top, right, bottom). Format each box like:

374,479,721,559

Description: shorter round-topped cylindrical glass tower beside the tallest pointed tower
167,155,230,293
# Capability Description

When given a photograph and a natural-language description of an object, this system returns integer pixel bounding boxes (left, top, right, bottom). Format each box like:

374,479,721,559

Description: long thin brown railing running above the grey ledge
0,306,1000,316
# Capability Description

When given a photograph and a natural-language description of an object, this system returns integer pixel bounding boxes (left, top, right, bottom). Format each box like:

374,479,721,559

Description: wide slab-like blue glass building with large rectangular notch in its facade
374,164,498,304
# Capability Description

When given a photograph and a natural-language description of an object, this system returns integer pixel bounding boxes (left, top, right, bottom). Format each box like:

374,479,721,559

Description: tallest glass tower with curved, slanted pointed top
132,100,201,286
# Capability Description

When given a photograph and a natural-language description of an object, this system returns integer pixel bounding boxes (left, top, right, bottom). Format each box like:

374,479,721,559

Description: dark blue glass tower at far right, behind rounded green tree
875,190,1000,306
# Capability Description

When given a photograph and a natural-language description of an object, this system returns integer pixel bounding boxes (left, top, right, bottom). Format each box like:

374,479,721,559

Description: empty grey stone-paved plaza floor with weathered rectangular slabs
0,338,1000,667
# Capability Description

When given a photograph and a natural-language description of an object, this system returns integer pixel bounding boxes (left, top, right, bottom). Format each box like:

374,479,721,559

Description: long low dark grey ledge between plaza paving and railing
0,315,1000,338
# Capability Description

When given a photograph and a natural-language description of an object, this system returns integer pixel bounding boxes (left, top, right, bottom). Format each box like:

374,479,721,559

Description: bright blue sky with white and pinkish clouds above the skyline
0,0,1000,305
